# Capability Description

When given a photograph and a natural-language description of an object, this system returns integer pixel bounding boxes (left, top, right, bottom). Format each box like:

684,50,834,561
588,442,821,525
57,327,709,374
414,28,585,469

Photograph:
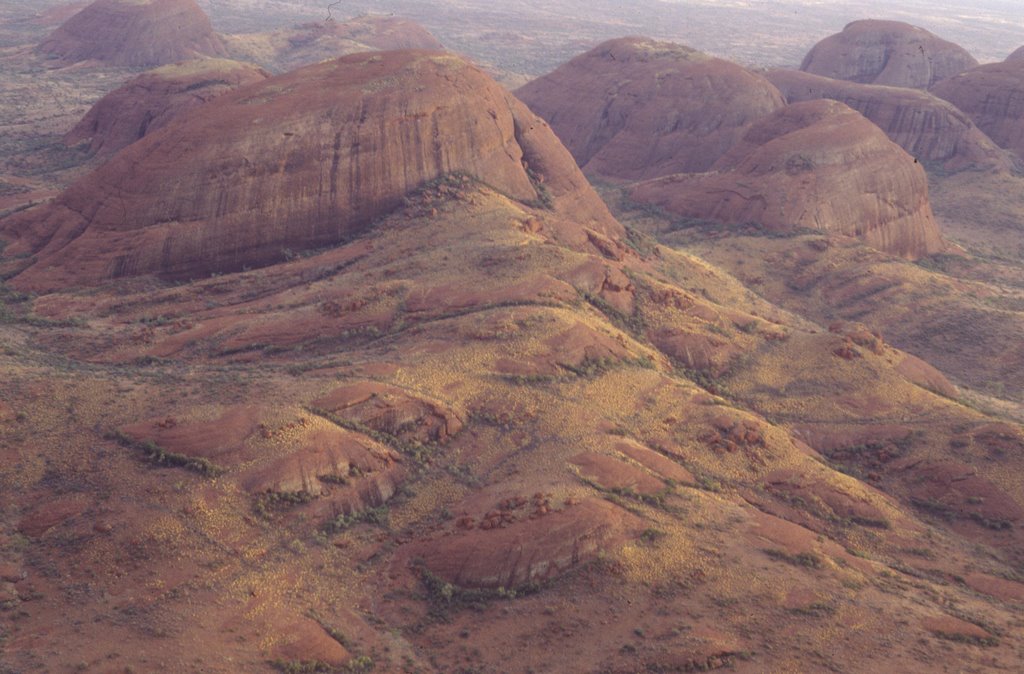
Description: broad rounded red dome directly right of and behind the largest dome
516,38,784,180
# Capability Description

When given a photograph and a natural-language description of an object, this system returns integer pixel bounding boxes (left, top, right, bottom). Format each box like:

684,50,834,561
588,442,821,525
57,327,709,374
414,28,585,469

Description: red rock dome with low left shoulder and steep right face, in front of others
633,100,943,258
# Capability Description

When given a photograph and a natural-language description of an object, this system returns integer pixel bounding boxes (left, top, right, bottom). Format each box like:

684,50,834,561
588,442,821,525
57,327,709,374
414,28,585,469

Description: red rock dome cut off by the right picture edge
932,59,1024,157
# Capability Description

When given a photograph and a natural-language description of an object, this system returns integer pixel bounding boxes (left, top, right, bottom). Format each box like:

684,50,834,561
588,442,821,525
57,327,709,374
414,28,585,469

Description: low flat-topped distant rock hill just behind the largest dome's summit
224,15,444,72
